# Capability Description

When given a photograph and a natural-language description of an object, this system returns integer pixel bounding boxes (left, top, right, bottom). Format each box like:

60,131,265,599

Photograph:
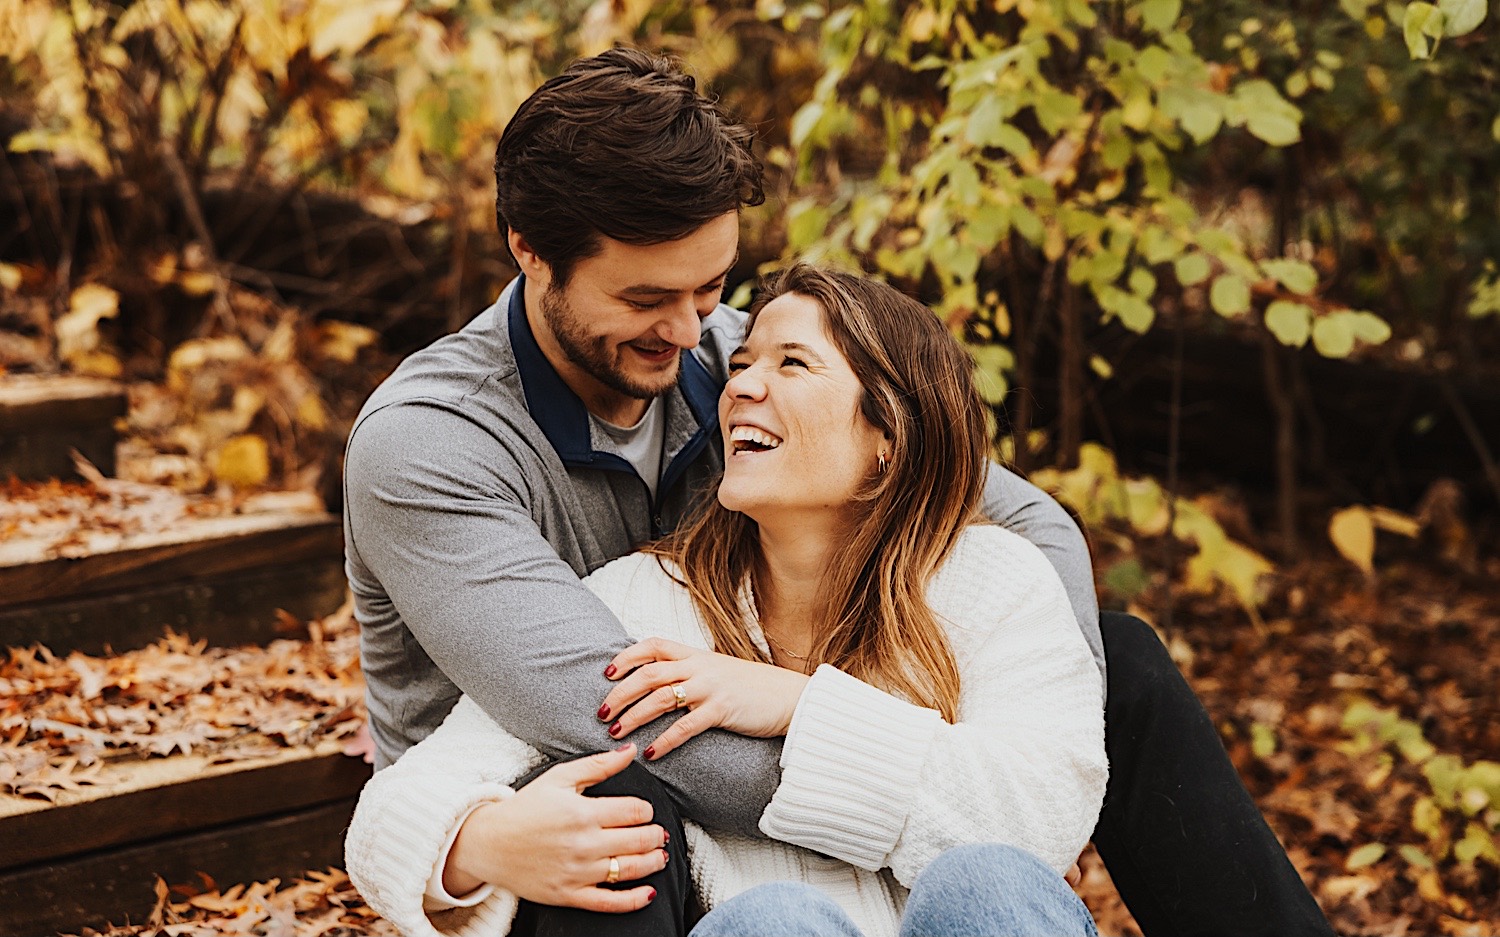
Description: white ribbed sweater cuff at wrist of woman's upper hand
761,664,942,871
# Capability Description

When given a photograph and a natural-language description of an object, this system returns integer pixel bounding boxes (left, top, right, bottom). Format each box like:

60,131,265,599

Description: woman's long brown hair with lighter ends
650,264,987,723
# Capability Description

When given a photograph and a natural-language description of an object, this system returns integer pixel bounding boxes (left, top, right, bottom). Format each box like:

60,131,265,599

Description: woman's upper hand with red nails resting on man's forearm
599,637,807,760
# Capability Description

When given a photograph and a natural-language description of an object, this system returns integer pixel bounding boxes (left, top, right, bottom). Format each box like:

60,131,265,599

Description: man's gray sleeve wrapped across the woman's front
345,403,782,835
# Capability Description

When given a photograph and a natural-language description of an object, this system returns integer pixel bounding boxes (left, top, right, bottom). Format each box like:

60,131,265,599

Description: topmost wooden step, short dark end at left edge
0,375,126,481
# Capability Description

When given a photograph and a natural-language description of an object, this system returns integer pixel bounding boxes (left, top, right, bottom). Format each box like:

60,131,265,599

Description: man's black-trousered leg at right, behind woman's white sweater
1094,612,1334,937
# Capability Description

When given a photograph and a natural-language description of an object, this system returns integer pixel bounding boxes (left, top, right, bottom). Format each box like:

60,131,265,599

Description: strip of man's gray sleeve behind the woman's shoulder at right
984,462,1104,678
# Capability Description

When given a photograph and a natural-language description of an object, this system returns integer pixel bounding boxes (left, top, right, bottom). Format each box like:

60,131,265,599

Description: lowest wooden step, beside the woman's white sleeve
0,742,371,937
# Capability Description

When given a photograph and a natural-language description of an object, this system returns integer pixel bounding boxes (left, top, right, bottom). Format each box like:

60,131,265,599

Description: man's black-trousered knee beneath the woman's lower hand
510,762,698,937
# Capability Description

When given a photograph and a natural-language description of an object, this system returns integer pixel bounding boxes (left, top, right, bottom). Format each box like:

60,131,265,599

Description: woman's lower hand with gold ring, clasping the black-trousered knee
443,745,668,913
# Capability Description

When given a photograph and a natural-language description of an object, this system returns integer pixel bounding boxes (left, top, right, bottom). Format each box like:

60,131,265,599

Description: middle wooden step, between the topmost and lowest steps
0,511,345,654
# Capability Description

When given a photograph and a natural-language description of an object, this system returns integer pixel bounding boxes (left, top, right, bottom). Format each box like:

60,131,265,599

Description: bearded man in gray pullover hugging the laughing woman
345,49,1331,937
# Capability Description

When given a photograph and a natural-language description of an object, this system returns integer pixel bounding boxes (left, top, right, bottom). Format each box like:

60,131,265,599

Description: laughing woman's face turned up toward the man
719,294,887,523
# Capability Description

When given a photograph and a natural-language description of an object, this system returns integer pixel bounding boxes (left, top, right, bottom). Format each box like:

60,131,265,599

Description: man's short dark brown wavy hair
495,48,765,286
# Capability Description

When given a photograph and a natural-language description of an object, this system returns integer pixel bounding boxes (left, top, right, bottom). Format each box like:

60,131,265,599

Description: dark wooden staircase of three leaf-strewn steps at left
0,370,371,937
